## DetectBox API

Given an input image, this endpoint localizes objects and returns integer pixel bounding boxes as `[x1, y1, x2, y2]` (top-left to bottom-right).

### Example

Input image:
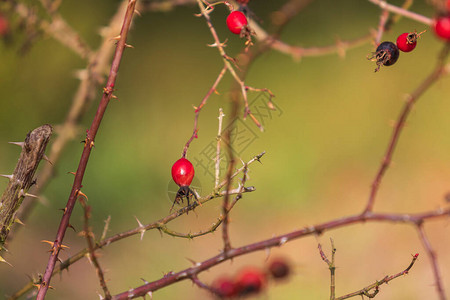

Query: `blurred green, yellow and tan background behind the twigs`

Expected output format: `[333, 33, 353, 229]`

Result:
[0, 0, 450, 299]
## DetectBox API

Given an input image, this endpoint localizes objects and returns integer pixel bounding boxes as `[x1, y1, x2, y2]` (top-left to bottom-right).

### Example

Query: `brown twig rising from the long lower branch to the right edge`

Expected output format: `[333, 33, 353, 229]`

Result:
[363, 43, 450, 214]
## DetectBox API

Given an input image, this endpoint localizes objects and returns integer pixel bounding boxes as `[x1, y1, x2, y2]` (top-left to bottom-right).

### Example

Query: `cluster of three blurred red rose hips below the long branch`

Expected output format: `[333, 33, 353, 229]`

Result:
[212, 258, 291, 299]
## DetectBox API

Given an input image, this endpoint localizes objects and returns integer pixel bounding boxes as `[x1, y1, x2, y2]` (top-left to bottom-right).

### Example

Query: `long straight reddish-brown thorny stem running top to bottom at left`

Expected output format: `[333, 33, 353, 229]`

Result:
[36, 0, 136, 300]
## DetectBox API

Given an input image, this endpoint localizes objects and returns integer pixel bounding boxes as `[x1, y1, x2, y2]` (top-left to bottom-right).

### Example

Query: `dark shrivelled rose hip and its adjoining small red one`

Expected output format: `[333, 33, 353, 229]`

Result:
[369, 31, 425, 72]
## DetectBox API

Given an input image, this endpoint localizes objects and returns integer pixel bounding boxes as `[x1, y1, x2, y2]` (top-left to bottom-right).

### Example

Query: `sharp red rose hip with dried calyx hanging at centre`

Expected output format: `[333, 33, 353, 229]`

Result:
[171, 157, 197, 210]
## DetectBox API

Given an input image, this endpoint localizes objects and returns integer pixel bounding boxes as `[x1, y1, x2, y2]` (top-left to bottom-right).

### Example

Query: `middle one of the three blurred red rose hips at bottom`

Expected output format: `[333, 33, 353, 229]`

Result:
[236, 267, 266, 296]
